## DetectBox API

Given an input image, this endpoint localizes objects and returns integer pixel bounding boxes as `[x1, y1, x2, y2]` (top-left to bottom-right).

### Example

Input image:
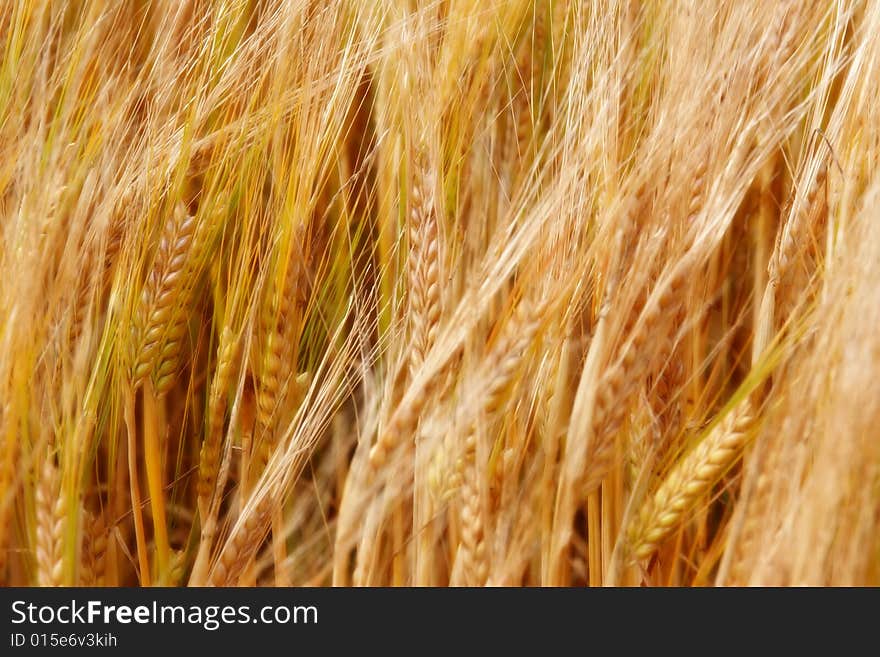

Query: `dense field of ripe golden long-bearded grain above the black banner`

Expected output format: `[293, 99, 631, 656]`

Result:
[0, 0, 880, 586]
